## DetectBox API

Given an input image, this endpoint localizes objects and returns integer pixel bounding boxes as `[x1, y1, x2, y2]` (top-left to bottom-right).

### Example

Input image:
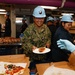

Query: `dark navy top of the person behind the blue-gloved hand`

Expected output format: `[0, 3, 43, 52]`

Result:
[52, 26, 73, 62]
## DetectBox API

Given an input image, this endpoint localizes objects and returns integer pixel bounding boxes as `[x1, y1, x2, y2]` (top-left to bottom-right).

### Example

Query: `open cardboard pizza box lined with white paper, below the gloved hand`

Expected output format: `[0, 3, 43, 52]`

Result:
[36, 53, 75, 75]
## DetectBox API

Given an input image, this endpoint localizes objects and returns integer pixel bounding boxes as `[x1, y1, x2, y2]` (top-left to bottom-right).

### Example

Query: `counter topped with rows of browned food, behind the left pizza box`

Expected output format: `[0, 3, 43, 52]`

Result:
[0, 37, 22, 55]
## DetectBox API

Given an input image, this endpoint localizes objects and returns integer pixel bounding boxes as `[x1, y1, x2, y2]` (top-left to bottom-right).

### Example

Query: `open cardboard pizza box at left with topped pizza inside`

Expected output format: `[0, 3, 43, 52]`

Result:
[0, 54, 30, 75]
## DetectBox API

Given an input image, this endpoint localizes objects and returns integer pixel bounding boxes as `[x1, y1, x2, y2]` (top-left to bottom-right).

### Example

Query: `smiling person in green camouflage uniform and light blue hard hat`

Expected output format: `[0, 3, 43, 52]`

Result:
[22, 6, 51, 71]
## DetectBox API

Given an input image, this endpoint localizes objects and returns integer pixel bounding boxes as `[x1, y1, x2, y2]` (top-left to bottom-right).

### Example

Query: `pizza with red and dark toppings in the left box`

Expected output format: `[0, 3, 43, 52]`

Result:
[4, 64, 24, 75]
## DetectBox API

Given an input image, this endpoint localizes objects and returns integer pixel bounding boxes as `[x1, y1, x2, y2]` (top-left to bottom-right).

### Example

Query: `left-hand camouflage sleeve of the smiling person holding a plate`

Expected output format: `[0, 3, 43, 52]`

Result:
[22, 28, 33, 52]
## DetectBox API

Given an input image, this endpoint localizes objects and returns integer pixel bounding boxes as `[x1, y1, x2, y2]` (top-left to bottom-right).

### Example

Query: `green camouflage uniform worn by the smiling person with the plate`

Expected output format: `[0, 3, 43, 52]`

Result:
[22, 23, 51, 60]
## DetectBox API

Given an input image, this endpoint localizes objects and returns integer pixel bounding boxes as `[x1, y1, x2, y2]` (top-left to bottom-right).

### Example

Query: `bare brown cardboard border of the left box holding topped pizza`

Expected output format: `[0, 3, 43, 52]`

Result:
[0, 54, 30, 75]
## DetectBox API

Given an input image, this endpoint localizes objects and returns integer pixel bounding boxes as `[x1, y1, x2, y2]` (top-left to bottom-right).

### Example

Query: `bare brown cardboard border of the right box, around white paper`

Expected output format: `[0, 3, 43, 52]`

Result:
[36, 61, 74, 75]
